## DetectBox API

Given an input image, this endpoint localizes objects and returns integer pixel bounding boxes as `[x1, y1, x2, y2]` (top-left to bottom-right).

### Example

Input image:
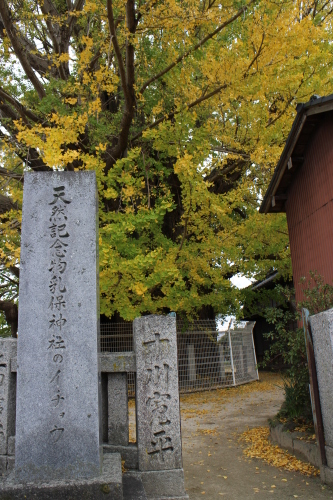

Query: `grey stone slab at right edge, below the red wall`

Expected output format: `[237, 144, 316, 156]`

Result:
[309, 309, 333, 447]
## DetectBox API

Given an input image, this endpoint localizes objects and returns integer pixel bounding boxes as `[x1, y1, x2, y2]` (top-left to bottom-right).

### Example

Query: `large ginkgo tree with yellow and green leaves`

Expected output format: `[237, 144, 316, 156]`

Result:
[0, 0, 333, 331]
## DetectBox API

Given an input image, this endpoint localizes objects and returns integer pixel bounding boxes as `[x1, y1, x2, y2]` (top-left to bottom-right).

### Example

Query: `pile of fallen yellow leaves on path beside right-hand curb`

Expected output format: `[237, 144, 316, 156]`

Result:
[239, 427, 319, 478]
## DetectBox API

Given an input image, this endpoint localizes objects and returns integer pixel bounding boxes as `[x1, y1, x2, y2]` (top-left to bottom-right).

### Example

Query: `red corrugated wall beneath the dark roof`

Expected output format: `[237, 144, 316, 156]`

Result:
[286, 120, 333, 301]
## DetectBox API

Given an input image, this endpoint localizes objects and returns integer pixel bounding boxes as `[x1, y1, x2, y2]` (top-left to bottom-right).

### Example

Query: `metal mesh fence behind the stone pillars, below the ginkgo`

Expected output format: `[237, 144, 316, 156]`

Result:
[100, 319, 259, 396]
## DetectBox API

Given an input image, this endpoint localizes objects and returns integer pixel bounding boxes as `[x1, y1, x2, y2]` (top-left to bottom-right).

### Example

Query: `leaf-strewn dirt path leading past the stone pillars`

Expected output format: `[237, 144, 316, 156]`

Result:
[181, 374, 333, 500]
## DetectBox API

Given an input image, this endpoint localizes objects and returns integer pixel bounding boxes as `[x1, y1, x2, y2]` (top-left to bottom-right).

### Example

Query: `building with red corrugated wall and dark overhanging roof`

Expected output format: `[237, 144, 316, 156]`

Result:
[260, 94, 333, 302]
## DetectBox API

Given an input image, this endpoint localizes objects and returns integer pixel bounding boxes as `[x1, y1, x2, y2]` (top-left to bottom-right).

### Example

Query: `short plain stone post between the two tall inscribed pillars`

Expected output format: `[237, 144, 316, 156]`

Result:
[108, 373, 129, 446]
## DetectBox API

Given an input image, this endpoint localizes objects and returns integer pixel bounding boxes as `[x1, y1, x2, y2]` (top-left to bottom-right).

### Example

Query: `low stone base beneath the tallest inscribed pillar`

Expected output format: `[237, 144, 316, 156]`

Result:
[0, 454, 123, 500]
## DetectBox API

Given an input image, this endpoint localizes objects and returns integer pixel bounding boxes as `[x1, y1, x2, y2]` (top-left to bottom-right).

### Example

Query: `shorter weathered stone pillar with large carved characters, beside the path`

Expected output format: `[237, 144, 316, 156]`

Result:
[133, 316, 182, 471]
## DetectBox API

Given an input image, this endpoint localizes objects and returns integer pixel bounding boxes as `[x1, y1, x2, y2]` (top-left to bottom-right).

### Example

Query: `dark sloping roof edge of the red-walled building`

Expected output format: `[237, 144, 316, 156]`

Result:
[259, 94, 333, 214]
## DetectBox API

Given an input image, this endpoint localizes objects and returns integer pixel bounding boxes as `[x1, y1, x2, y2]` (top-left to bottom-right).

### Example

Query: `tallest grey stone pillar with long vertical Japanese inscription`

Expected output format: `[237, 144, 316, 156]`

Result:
[15, 172, 101, 481]
